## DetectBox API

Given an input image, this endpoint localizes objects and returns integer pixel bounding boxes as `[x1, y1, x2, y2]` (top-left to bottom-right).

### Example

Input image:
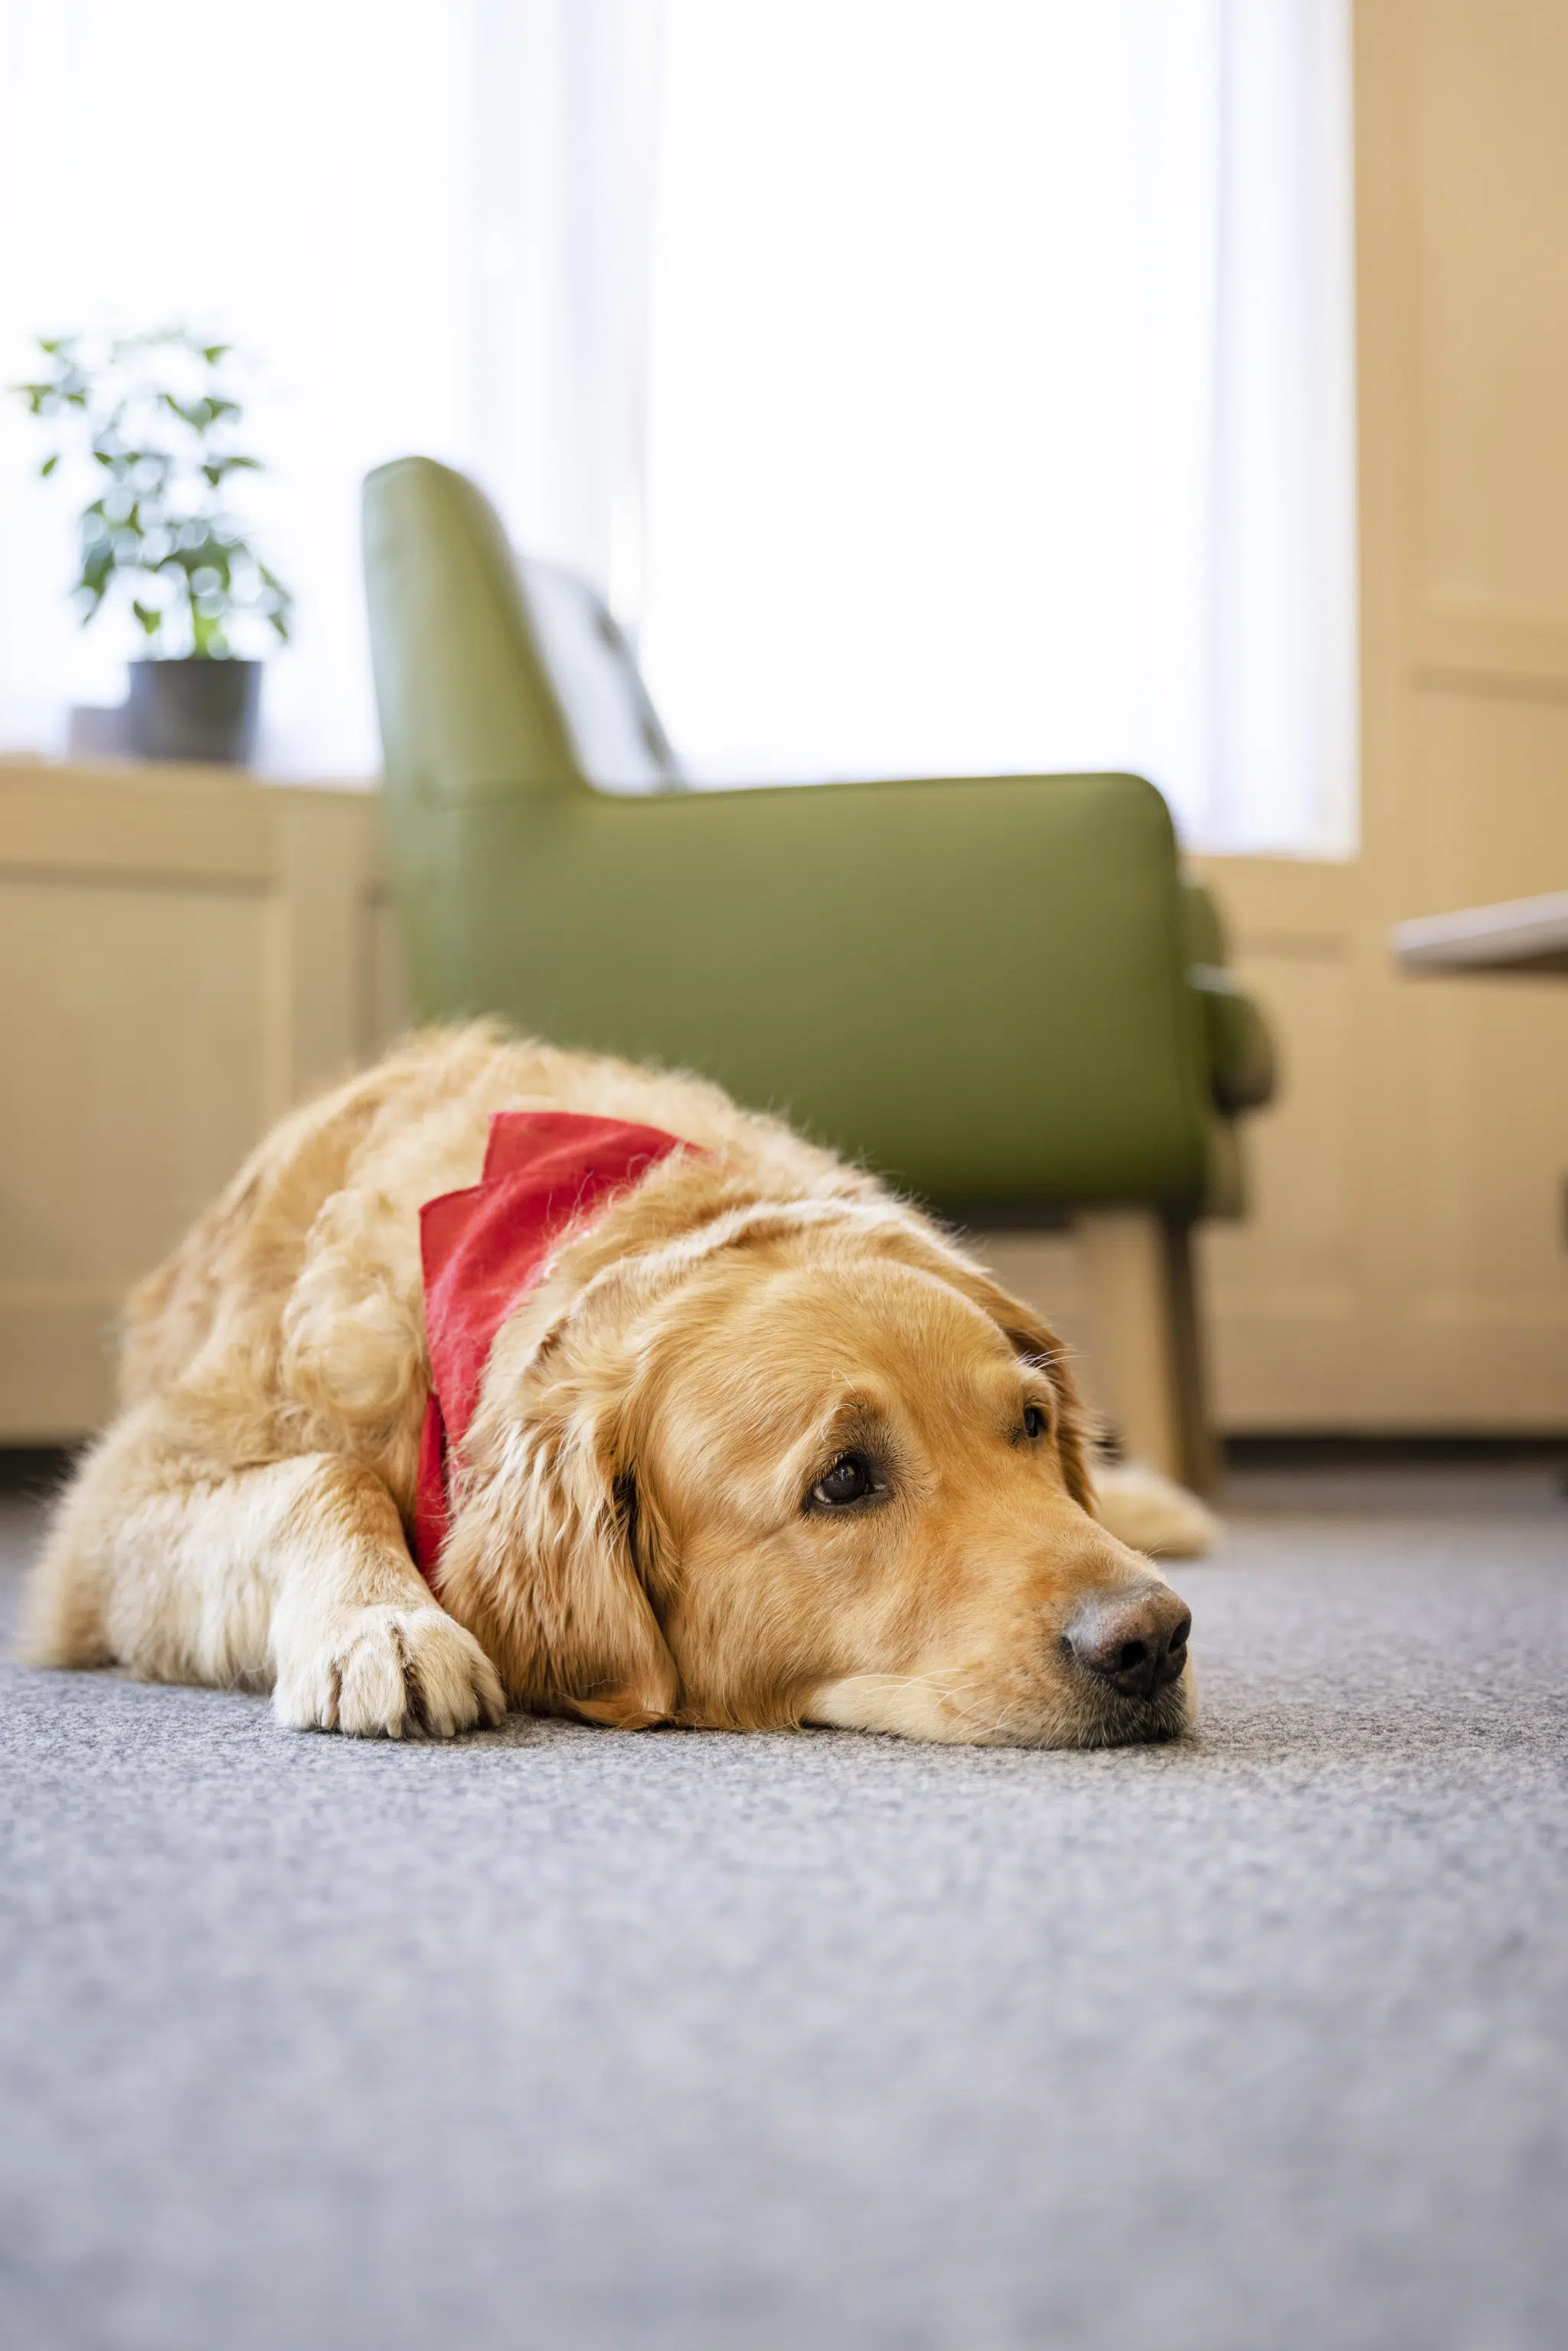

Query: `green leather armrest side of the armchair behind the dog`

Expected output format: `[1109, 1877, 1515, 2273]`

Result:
[388, 776, 1208, 1206]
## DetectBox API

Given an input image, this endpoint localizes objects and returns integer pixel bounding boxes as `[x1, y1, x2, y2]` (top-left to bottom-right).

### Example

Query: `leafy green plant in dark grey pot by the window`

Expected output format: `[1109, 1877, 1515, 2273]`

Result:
[11, 327, 292, 764]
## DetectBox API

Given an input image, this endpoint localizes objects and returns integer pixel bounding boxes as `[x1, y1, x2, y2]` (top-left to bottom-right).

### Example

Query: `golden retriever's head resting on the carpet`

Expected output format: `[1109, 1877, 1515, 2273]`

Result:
[442, 1201, 1190, 1747]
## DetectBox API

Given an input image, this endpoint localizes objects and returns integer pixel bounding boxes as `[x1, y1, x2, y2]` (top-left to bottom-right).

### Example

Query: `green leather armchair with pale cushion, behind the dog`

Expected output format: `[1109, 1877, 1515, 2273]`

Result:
[364, 456, 1272, 1484]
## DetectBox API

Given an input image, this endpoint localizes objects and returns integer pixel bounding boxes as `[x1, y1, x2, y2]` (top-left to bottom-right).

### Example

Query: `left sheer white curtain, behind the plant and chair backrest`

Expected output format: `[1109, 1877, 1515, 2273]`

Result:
[0, 0, 658, 779]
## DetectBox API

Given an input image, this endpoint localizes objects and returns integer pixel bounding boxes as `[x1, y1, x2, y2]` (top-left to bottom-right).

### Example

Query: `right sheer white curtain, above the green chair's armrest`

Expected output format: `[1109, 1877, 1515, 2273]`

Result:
[644, 0, 1357, 849]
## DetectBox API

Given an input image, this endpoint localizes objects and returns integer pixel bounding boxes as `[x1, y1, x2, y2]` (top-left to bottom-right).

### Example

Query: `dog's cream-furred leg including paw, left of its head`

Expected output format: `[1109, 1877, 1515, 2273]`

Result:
[26, 1406, 505, 1737]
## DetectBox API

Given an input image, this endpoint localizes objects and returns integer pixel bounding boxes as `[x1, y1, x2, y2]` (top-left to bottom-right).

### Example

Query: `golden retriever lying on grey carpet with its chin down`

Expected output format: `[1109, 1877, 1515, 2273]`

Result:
[28, 1027, 1192, 1747]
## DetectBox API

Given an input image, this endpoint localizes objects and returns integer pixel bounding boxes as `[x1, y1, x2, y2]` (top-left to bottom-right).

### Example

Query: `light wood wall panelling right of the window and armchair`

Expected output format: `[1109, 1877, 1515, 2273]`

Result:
[1184, 0, 1568, 1432]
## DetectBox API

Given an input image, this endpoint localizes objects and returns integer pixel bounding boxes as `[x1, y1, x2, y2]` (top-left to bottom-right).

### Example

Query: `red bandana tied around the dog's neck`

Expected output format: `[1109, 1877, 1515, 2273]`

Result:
[413, 1110, 684, 1582]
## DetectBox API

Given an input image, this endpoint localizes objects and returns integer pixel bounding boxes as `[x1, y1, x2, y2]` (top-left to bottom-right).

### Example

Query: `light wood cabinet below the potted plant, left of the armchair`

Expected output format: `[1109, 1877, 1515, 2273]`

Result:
[0, 759, 402, 1444]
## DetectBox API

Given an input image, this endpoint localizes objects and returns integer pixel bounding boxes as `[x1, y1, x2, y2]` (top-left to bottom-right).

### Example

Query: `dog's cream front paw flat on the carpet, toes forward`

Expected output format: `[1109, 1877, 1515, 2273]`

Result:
[273, 1608, 505, 1740]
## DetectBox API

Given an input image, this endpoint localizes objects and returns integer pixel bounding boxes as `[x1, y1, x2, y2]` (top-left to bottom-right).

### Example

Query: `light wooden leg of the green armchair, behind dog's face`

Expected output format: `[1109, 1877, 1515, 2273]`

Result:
[1076, 1208, 1218, 1493]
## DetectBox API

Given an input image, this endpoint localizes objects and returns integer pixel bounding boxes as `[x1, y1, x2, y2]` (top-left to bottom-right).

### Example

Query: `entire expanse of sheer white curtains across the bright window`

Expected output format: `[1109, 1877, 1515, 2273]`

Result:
[0, 0, 1357, 851]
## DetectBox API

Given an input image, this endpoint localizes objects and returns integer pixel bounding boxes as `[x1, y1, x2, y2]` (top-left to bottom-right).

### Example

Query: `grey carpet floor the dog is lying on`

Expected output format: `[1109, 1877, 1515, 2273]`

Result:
[0, 1471, 1568, 2351]
